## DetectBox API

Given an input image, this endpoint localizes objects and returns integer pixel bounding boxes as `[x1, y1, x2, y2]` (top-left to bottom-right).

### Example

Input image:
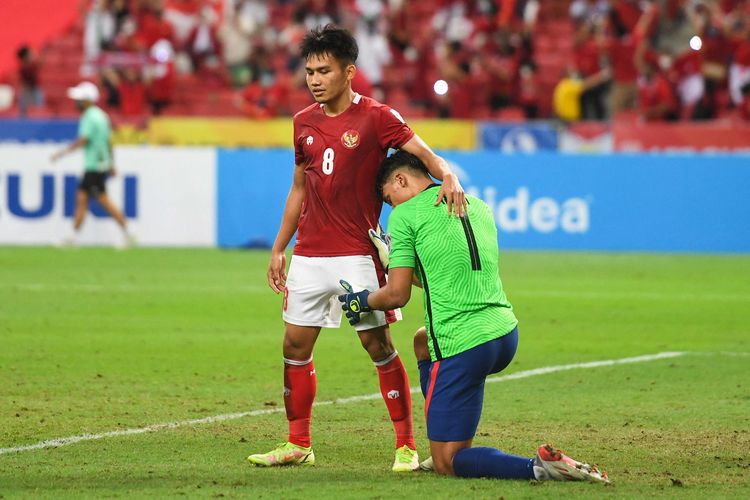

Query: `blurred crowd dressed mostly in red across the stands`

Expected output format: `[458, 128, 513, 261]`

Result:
[10, 0, 750, 122]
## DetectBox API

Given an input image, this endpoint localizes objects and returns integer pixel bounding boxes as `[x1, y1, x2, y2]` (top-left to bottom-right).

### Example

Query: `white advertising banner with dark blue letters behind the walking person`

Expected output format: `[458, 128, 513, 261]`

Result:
[0, 144, 216, 246]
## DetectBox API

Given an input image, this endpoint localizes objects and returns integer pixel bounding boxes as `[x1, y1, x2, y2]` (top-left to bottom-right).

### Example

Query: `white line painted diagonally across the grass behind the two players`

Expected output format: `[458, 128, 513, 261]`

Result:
[0, 352, 688, 455]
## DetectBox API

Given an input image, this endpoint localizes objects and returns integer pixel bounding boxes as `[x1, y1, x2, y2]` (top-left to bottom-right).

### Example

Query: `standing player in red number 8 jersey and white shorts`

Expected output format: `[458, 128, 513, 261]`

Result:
[248, 25, 465, 472]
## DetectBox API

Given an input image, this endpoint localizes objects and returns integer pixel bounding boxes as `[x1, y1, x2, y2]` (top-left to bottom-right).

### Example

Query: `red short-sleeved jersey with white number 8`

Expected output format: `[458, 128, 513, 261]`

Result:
[294, 94, 414, 262]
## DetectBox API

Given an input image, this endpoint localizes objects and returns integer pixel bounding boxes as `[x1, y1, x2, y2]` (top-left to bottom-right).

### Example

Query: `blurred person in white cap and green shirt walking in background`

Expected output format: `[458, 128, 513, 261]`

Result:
[52, 82, 134, 247]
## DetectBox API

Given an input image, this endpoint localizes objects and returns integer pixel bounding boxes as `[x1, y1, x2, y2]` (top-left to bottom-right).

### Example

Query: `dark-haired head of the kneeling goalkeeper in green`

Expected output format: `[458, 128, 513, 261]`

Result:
[375, 150, 433, 207]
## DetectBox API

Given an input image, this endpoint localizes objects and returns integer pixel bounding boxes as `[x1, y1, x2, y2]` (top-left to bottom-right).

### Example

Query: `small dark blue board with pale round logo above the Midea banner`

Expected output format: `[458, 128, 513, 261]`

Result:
[479, 122, 558, 153]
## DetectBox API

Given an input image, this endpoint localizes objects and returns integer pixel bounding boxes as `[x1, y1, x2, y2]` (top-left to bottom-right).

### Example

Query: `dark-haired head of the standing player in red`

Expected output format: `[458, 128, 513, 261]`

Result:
[300, 24, 359, 103]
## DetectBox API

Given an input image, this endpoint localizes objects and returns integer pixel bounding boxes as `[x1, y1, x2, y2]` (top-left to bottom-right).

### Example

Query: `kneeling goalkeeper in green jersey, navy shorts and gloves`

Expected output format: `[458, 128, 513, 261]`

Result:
[339, 151, 607, 482]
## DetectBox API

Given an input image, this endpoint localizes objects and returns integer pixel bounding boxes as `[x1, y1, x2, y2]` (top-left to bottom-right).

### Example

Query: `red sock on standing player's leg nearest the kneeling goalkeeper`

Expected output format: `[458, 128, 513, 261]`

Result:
[375, 352, 417, 450]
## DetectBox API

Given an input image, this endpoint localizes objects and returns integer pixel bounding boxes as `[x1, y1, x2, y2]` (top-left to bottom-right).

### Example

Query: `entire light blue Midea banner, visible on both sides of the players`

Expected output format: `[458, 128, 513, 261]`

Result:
[217, 150, 750, 252]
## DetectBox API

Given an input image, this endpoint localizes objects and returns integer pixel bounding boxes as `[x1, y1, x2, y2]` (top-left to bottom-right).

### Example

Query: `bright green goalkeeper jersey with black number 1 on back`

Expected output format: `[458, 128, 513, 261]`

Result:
[388, 185, 518, 361]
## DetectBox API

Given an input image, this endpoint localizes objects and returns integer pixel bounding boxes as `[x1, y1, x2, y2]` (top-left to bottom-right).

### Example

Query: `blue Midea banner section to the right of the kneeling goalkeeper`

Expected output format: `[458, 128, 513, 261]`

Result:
[444, 153, 750, 252]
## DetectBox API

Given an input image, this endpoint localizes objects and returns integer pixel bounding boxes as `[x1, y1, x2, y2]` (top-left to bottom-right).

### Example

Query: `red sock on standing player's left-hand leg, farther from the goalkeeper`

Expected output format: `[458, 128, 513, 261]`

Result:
[284, 358, 317, 448]
